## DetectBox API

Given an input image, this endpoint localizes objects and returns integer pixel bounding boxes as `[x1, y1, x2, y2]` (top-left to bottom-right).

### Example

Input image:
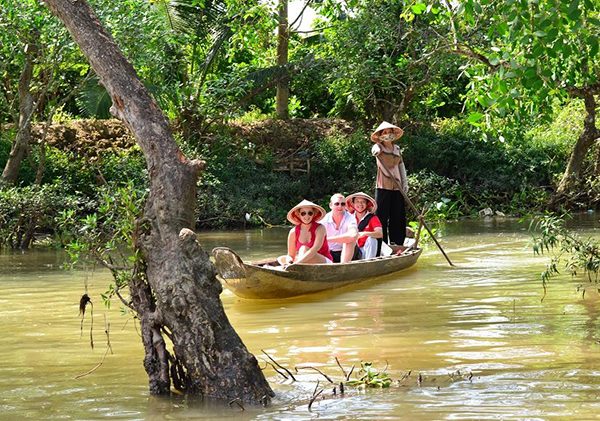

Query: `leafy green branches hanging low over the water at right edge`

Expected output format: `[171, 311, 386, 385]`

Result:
[530, 215, 600, 289]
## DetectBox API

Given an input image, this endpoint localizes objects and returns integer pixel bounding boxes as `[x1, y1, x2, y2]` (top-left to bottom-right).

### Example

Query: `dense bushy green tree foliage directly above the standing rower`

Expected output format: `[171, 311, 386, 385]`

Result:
[318, 0, 458, 121]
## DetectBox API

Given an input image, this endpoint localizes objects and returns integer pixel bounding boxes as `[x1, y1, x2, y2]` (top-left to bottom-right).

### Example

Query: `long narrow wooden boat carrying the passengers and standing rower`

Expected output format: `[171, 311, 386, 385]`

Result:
[212, 247, 421, 299]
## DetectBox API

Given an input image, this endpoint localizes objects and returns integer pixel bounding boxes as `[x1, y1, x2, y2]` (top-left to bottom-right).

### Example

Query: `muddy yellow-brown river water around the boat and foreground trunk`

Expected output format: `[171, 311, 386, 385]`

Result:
[0, 217, 600, 420]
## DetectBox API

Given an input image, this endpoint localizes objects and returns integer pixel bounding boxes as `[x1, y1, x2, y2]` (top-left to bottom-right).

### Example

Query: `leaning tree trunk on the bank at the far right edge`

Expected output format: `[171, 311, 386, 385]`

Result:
[552, 91, 600, 203]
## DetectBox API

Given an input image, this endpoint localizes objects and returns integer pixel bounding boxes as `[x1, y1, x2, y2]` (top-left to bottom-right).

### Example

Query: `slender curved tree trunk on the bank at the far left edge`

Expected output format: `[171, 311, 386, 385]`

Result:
[2, 44, 38, 184]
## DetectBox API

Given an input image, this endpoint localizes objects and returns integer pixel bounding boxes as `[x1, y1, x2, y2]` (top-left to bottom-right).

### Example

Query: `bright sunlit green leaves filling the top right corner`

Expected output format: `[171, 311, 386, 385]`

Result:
[434, 0, 600, 125]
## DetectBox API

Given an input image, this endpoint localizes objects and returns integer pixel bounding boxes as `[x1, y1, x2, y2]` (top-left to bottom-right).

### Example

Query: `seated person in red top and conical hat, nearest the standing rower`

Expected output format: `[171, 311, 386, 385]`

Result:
[346, 192, 383, 259]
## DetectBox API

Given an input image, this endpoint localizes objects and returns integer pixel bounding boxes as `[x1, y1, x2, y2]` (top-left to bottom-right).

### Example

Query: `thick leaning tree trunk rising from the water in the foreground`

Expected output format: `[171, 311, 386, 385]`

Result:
[45, 0, 273, 404]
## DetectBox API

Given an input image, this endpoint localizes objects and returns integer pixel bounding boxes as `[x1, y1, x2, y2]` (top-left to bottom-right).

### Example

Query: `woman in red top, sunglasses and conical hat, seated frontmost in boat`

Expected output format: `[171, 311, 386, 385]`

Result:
[277, 200, 333, 265]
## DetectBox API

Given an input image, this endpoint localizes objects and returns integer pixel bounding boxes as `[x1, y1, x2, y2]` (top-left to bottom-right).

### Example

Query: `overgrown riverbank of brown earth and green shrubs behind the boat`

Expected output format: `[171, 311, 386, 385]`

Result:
[0, 115, 600, 246]
